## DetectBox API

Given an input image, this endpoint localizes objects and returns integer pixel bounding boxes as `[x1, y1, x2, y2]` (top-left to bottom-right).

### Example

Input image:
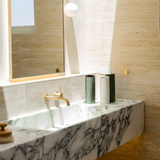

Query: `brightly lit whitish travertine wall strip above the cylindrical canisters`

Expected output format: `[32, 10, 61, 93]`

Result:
[86, 0, 116, 72]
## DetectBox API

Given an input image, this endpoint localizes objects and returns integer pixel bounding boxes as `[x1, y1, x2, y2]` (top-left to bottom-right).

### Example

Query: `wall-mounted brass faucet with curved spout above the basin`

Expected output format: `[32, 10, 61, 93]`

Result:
[44, 87, 70, 106]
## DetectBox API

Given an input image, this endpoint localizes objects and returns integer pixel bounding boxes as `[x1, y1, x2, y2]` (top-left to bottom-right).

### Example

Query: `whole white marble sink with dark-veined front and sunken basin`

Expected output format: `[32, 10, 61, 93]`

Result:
[0, 99, 144, 160]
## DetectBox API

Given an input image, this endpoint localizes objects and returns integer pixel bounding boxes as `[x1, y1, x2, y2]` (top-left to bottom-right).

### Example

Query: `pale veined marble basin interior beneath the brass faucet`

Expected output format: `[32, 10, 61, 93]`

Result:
[3, 100, 140, 131]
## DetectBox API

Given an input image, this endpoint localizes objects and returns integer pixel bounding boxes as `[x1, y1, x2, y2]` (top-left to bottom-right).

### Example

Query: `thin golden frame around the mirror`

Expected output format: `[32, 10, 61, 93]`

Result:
[8, 0, 66, 83]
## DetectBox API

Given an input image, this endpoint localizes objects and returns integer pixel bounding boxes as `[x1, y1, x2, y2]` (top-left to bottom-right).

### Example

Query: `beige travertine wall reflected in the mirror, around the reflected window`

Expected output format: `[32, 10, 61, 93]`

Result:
[12, 0, 63, 78]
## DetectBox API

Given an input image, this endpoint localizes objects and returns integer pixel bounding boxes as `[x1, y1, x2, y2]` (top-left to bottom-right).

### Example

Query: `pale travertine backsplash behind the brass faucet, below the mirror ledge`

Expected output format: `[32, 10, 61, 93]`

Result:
[0, 75, 91, 121]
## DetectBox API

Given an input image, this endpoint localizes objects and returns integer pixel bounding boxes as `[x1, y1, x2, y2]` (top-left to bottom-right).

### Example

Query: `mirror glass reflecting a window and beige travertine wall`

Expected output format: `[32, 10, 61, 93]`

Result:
[10, 0, 65, 79]
